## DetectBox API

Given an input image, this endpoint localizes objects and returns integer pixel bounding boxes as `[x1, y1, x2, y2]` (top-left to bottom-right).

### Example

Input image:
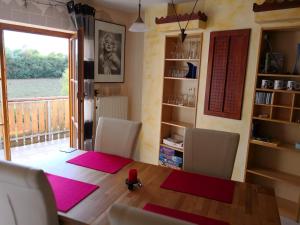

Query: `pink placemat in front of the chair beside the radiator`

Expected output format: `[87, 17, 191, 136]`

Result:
[67, 152, 132, 173]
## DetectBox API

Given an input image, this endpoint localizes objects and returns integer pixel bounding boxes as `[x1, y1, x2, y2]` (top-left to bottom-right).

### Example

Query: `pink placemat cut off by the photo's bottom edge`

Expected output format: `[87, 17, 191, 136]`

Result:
[144, 203, 229, 225]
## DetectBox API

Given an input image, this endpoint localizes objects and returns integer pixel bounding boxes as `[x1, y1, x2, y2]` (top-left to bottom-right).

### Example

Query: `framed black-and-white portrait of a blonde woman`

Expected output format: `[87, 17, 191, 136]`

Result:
[95, 20, 126, 83]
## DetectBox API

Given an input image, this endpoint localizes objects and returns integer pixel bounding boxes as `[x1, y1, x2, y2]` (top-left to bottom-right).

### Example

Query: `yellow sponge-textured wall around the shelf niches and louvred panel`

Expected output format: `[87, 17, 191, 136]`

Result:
[139, 0, 299, 180]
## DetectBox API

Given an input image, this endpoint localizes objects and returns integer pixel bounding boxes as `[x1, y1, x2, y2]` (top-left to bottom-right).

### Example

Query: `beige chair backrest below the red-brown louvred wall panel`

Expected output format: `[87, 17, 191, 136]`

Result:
[184, 128, 240, 179]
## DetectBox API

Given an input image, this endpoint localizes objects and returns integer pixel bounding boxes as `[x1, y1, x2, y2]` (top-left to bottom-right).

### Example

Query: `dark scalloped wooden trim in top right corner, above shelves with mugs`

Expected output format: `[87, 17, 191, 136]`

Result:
[253, 0, 300, 12]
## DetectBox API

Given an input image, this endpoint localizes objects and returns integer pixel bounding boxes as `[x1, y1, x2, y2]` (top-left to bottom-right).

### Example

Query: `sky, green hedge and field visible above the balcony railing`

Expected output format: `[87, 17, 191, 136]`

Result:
[4, 31, 68, 99]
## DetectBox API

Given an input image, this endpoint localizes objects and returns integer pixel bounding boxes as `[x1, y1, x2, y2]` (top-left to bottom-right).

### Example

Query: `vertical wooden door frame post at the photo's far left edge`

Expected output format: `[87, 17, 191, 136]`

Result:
[0, 29, 11, 160]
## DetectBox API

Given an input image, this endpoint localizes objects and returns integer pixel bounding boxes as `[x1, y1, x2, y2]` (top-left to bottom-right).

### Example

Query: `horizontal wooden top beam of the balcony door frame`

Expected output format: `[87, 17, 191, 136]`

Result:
[0, 23, 75, 38]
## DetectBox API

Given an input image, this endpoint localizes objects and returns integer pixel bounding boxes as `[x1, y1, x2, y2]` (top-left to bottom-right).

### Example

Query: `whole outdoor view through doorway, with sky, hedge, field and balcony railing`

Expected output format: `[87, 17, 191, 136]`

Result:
[0, 31, 69, 160]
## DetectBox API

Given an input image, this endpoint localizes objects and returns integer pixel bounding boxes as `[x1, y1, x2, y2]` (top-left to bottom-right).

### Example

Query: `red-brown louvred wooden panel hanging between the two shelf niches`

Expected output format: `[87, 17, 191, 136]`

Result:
[204, 29, 250, 119]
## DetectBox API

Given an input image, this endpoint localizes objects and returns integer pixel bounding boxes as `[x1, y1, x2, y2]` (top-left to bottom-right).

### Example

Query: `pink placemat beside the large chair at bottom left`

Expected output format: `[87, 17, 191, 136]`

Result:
[46, 173, 99, 212]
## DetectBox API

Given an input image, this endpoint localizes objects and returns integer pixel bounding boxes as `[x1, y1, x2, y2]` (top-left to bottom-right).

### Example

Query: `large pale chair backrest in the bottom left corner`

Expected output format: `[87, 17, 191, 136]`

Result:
[0, 161, 58, 225]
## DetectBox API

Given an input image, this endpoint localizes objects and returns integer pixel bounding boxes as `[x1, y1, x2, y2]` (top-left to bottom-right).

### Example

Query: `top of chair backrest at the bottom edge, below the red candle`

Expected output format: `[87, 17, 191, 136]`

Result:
[108, 204, 194, 225]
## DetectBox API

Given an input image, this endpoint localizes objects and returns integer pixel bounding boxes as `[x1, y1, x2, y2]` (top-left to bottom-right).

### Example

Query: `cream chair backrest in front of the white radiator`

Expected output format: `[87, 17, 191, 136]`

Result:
[94, 117, 141, 158]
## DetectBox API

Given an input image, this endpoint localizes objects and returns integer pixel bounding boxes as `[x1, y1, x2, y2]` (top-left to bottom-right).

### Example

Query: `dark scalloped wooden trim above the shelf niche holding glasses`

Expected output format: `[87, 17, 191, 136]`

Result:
[155, 11, 207, 24]
